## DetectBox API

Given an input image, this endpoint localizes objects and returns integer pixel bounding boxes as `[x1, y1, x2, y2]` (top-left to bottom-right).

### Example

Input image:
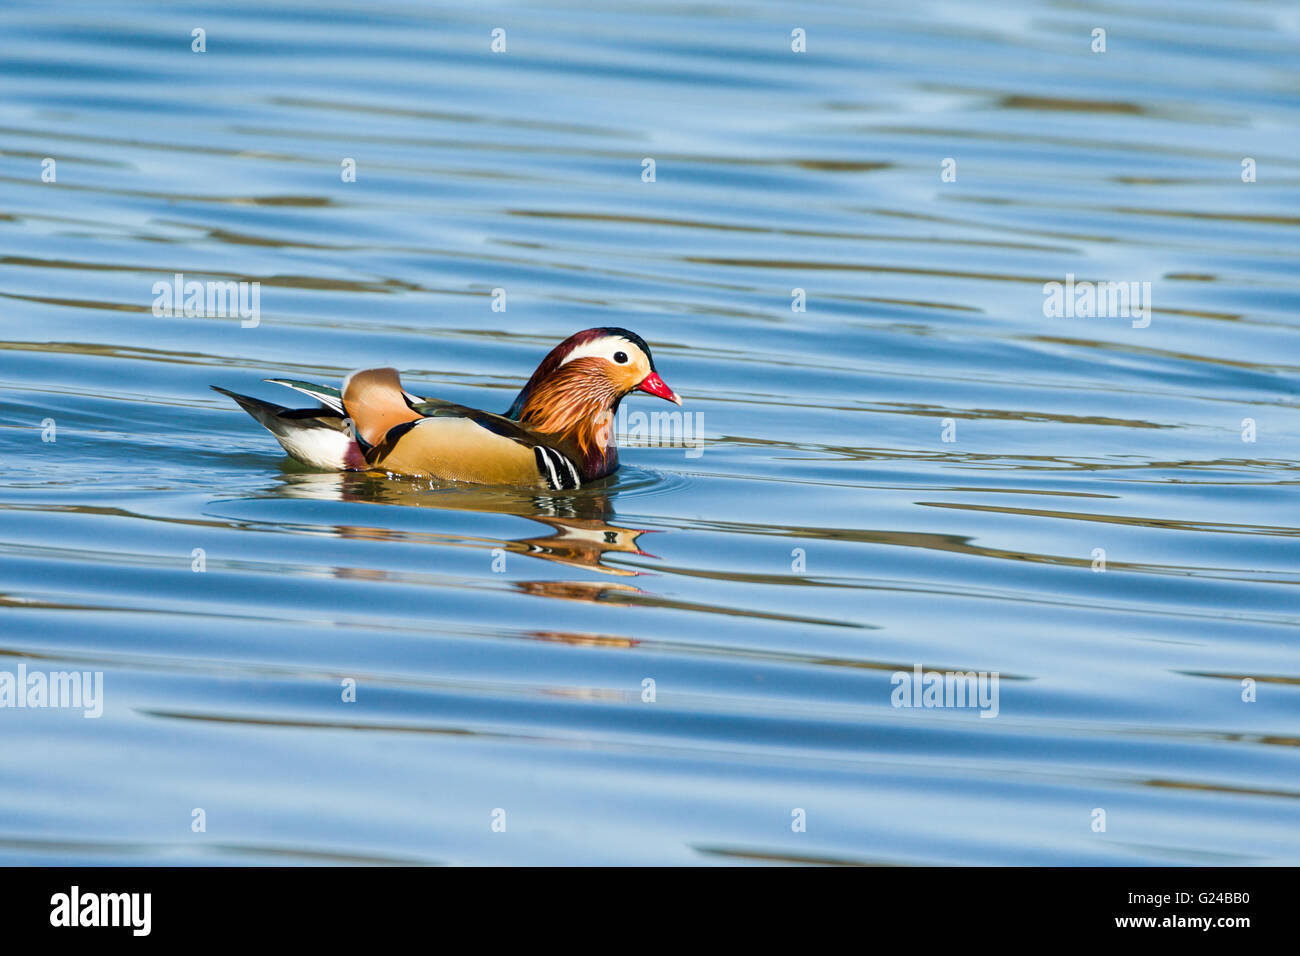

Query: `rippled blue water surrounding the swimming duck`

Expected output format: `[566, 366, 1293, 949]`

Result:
[0, 0, 1300, 864]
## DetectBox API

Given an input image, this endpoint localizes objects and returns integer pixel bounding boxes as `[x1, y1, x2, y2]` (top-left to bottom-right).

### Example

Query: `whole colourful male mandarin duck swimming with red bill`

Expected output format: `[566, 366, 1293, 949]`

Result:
[212, 328, 681, 490]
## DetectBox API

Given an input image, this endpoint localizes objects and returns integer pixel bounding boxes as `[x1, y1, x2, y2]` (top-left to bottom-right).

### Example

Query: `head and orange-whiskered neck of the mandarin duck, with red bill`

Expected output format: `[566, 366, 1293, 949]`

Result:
[506, 328, 681, 477]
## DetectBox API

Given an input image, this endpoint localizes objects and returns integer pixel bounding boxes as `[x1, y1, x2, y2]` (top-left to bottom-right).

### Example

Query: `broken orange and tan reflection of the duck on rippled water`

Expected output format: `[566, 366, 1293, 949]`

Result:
[276, 472, 655, 580]
